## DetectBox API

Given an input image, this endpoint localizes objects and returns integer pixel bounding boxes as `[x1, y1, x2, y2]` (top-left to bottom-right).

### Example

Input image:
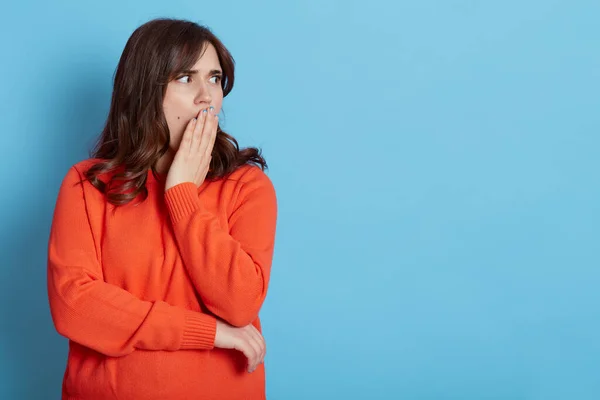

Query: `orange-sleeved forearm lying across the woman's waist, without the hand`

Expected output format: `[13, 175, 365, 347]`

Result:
[48, 263, 216, 357]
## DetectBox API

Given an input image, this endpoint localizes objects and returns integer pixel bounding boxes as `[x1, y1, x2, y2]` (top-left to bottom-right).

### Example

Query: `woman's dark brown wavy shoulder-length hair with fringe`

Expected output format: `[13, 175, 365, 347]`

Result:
[85, 18, 267, 206]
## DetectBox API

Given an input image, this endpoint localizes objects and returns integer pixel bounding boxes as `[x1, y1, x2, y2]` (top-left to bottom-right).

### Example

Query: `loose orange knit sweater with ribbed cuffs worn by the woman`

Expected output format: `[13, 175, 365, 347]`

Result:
[48, 160, 277, 400]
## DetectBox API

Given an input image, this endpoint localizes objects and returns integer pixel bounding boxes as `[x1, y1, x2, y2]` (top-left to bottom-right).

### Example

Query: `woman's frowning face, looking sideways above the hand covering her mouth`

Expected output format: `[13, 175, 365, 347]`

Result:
[163, 44, 223, 151]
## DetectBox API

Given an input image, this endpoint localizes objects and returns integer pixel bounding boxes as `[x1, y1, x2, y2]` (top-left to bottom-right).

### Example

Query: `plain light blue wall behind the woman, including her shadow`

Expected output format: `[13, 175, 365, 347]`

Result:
[0, 0, 600, 400]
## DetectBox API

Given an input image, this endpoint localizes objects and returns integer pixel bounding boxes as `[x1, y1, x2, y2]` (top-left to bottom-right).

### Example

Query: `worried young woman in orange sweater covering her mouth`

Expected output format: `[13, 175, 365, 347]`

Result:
[48, 19, 277, 400]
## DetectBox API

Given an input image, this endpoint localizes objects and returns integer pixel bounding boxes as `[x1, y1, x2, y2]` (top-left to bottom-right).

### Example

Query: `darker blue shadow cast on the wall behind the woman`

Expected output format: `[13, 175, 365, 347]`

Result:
[0, 58, 113, 399]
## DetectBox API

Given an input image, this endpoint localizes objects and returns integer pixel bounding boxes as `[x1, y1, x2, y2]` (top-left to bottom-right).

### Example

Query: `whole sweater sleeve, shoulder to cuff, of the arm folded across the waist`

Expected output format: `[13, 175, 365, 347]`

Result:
[47, 167, 216, 357]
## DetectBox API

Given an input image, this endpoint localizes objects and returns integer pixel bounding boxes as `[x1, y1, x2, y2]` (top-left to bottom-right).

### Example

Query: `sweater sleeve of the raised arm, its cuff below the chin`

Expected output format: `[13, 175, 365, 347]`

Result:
[165, 167, 277, 326]
